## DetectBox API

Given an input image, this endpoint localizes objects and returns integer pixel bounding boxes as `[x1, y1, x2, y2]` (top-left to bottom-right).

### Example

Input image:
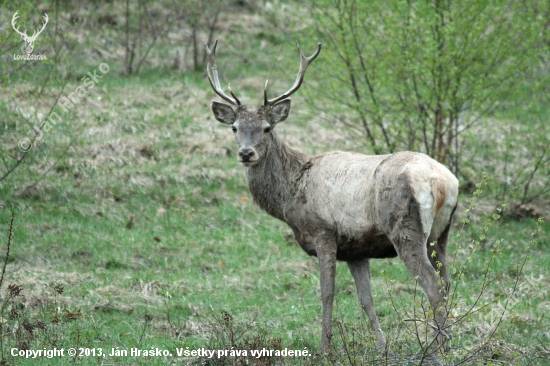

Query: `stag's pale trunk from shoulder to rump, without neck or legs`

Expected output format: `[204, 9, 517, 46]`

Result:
[281, 152, 456, 261]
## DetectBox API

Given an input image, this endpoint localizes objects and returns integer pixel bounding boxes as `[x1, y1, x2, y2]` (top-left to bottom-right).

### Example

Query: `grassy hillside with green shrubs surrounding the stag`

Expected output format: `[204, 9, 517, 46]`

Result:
[0, 0, 550, 365]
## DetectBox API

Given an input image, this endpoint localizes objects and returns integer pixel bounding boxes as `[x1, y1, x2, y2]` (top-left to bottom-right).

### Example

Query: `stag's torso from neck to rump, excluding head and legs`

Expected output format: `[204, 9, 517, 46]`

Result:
[246, 143, 456, 261]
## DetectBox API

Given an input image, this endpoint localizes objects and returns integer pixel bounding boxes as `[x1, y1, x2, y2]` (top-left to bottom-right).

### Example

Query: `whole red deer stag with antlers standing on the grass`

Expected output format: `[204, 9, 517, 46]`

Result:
[205, 40, 458, 351]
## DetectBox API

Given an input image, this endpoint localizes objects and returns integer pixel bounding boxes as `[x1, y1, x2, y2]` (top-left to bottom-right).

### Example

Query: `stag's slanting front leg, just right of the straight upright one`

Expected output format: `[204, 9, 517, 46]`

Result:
[347, 258, 386, 350]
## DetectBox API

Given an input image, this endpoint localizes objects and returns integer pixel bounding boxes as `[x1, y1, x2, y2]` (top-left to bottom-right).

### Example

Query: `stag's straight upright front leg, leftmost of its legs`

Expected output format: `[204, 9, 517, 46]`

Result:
[316, 242, 336, 352]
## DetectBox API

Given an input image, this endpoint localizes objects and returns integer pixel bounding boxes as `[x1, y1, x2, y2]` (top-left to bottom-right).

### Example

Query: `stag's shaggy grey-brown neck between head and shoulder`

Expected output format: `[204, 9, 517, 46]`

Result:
[246, 131, 309, 222]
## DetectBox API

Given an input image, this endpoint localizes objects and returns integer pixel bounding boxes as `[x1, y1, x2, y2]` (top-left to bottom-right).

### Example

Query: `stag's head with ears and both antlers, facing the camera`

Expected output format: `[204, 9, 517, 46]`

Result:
[205, 40, 321, 167]
